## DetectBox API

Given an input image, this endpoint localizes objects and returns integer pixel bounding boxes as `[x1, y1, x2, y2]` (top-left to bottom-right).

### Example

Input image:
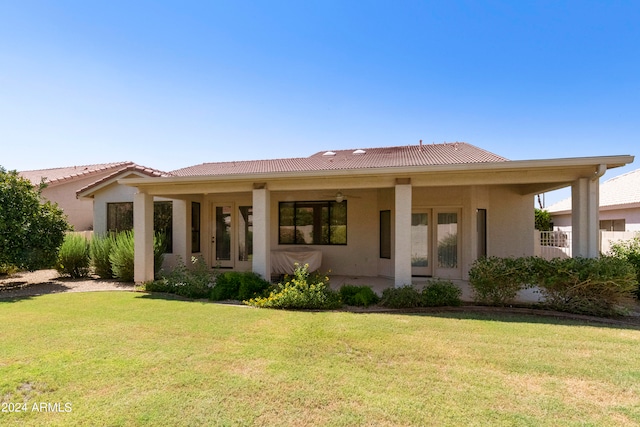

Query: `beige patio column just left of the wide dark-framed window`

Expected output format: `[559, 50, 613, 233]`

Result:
[252, 183, 271, 280]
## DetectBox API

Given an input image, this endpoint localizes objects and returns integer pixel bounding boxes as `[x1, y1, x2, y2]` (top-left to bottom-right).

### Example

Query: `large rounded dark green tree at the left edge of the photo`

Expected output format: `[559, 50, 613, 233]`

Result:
[0, 166, 71, 271]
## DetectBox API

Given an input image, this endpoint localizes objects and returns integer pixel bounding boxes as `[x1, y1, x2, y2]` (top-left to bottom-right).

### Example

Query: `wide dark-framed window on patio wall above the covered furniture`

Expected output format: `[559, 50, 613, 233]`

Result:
[278, 201, 347, 245]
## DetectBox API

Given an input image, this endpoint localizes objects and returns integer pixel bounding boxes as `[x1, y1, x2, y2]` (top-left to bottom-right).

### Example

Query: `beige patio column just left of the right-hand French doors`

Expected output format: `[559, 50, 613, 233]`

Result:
[393, 178, 412, 288]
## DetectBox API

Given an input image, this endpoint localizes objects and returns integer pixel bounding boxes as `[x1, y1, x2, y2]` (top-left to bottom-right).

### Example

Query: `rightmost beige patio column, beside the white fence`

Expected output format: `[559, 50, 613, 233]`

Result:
[571, 178, 600, 258]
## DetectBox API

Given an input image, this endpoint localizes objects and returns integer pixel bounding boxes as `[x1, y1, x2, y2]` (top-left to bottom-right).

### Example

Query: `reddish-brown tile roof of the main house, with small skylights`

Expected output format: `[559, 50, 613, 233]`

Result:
[171, 142, 507, 176]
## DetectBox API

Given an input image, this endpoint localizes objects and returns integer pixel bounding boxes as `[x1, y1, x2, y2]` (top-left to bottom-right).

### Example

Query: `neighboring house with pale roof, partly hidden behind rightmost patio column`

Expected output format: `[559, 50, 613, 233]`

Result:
[547, 169, 640, 231]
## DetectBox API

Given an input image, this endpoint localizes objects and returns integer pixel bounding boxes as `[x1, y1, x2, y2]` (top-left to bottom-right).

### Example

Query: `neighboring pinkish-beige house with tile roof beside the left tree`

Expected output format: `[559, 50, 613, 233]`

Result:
[20, 162, 159, 231]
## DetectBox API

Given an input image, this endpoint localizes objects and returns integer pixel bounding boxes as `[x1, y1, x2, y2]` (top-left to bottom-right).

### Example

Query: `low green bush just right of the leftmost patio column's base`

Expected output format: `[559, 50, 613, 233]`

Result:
[145, 257, 214, 298]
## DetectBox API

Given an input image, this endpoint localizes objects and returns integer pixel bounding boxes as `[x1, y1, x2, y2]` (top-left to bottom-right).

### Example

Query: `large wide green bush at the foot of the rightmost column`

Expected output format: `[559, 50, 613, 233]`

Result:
[532, 256, 638, 316]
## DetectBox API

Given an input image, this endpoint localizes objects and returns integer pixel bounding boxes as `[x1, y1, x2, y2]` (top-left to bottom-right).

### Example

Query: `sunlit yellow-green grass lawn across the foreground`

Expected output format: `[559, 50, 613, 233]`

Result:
[0, 292, 640, 426]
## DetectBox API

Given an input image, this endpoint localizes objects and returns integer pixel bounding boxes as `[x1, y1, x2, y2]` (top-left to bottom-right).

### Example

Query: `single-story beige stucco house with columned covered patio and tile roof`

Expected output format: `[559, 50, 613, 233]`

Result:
[78, 142, 633, 286]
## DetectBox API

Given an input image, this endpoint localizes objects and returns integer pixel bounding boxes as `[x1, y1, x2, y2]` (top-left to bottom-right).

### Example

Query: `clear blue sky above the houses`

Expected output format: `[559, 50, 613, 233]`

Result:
[0, 0, 640, 206]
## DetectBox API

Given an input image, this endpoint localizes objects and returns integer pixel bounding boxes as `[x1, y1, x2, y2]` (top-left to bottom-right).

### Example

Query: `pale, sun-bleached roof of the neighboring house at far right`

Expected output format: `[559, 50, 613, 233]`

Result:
[547, 169, 640, 212]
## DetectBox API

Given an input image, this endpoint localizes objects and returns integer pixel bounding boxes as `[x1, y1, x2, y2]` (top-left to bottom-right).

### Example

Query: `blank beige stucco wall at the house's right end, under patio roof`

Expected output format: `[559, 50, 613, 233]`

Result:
[487, 187, 535, 257]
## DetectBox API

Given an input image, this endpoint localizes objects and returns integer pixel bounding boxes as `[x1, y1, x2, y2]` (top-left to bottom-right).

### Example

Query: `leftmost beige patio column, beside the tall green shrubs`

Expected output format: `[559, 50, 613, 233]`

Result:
[133, 191, 153, 283]
